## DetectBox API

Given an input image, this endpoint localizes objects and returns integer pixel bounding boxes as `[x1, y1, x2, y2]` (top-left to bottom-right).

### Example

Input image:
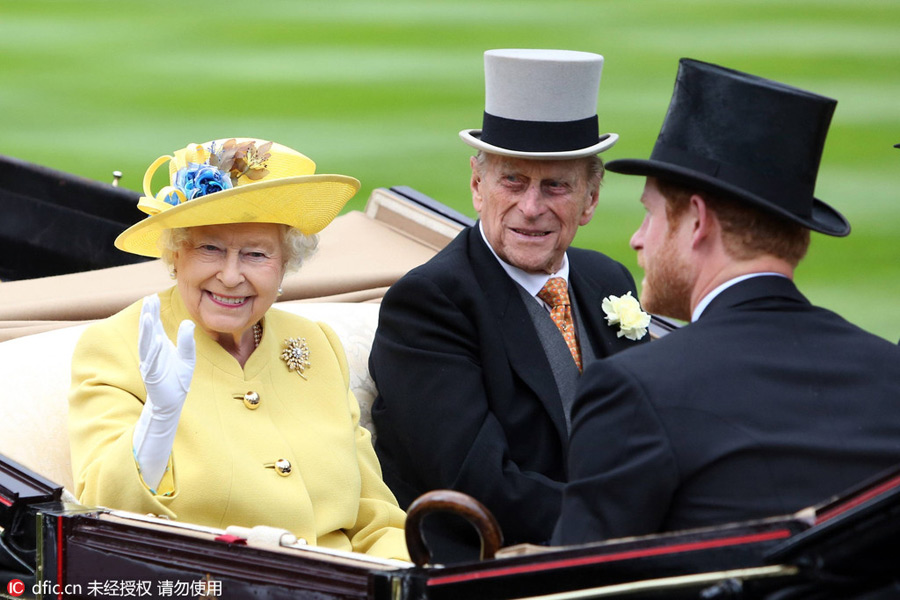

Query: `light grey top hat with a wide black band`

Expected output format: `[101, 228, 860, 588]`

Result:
[459, 49, 619, 160]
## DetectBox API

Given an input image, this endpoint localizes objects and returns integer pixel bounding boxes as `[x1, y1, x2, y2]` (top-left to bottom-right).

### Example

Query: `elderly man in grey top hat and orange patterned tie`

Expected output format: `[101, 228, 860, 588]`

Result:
[369, 50, 647, 562]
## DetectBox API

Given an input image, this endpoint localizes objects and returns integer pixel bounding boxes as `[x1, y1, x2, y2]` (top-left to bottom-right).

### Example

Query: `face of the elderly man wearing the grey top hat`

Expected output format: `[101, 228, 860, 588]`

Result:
[471, 155, 598, 273]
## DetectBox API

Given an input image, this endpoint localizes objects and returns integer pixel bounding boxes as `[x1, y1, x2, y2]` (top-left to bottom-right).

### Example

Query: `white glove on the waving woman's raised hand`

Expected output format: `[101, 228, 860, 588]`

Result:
[132, 294, 196, 489]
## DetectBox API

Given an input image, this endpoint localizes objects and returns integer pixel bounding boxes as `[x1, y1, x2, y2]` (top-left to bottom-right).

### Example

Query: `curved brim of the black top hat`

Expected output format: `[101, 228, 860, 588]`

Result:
[606, 158, 850, 237]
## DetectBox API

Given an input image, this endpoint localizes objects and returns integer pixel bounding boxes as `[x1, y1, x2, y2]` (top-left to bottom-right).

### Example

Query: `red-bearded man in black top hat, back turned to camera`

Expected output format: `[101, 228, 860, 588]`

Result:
[554, 60, 900, 544]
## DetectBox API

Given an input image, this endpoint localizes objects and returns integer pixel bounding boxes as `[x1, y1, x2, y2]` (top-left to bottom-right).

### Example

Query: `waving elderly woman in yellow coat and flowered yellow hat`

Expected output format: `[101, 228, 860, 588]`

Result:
[69, 139, 408, 559]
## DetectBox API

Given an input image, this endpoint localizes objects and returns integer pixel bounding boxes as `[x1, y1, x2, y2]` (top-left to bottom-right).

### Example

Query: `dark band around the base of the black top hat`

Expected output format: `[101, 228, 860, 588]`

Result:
[650, 141, 813, 217]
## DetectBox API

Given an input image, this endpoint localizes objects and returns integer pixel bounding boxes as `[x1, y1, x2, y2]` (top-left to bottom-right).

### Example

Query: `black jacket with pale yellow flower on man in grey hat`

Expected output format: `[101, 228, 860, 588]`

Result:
[369, 225, 649, 562]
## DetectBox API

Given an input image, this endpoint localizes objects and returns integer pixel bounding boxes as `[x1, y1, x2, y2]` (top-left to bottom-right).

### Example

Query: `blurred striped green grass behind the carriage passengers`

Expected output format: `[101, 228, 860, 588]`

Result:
[0, 0, 900, 341]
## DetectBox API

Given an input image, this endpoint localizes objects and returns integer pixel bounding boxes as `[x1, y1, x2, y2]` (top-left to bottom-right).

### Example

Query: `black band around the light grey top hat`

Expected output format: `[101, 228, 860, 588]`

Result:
[481, 113, 600, 152]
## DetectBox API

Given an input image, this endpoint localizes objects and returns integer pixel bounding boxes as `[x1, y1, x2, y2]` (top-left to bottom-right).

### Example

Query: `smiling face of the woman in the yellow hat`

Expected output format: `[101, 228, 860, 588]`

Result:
[173, 223, 284, 344]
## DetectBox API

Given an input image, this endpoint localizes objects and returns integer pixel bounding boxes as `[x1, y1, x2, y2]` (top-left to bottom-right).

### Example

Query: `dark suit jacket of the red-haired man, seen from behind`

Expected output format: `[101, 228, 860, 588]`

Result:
[554, 276, 900, 544]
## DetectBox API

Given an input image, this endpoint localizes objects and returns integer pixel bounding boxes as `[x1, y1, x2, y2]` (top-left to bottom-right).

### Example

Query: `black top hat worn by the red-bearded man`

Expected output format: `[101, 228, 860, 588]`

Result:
[607, 58, 850, 236]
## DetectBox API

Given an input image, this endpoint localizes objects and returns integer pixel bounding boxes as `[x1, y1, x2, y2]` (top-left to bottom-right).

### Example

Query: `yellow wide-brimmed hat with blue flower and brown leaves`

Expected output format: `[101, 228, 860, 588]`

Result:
[115, 138, 359, 257]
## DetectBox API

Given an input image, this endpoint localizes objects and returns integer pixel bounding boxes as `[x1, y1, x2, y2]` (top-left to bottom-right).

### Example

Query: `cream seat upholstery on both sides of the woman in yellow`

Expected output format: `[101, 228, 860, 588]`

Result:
[0, 302, 379, 490]
